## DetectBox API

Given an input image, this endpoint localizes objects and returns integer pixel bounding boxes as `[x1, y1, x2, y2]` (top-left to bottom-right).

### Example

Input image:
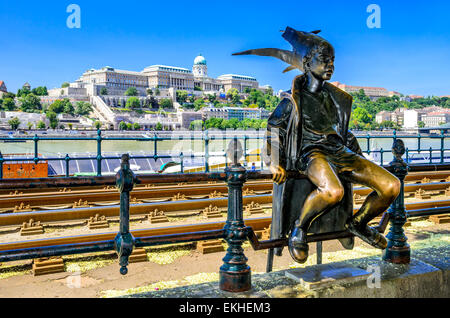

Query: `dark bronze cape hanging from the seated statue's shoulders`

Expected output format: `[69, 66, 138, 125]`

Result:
[264, 75, 360, 255]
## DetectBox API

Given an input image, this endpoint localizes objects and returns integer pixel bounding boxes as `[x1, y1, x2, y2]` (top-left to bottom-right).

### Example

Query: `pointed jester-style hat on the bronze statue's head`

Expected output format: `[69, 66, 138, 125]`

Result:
[233, 27, 331, 73]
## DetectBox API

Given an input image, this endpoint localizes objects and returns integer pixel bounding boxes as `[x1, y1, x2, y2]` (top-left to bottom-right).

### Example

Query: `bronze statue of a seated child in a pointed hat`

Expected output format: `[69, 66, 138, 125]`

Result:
[235, 27, 400, 263]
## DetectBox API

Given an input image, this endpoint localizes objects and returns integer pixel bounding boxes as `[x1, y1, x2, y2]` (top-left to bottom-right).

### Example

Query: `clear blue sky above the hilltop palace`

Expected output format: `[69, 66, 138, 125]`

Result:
[0, 0, 450, 96]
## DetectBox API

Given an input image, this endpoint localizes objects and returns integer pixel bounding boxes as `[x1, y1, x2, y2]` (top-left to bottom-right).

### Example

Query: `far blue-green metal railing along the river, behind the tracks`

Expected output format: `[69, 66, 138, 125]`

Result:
[0, 130, 450, 179]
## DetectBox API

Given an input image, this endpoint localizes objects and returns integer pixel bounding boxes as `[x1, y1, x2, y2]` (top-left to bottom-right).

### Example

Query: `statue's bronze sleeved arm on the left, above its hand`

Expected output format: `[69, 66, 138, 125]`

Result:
[263, 98, 293, 168]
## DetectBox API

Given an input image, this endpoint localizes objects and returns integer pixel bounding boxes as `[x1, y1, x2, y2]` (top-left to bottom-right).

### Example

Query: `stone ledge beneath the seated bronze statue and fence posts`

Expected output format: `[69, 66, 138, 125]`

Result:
[126, 246, 450, 298]
